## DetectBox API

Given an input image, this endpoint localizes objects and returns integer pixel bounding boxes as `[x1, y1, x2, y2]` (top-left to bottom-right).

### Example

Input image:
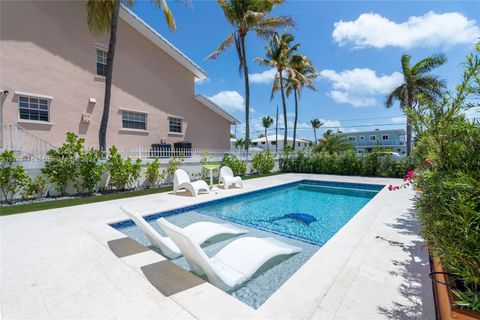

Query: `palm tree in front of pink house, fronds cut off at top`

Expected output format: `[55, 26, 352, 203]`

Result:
[86, 0, 176, 150]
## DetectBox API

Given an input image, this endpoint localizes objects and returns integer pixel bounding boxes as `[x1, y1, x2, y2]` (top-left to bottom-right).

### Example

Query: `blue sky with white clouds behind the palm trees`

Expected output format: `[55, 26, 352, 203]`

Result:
[134, 0, 480, 138]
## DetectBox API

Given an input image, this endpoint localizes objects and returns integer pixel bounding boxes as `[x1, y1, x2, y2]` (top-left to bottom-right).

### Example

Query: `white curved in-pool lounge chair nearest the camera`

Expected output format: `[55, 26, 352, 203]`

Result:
[157, 218, 302, 290]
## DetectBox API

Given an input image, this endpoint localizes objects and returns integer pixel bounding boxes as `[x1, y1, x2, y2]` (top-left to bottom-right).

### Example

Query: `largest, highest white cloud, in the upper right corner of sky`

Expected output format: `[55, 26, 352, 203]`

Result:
[332, 11, 480, 49]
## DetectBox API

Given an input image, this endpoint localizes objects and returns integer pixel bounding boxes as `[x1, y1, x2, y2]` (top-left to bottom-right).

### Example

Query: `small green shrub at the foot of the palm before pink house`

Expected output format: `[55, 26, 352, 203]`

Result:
[78, 149, 105, 194]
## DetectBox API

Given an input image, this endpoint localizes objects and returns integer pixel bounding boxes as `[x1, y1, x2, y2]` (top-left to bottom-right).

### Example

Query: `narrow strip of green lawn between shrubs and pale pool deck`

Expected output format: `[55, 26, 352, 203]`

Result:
[0, 172, 282, 216]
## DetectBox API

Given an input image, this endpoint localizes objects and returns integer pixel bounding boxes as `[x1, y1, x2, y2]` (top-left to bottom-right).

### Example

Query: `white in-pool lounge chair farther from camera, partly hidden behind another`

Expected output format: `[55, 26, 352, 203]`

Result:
[120, 206, 248, 259]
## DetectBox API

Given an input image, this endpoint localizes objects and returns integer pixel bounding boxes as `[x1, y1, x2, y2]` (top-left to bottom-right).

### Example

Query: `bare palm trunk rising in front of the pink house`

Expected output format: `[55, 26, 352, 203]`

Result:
[98, 0, 120, 151]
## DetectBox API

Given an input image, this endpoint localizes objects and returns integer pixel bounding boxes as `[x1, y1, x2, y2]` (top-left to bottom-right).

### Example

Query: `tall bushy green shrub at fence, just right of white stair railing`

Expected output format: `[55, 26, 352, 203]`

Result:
[42, 132, 85, 195]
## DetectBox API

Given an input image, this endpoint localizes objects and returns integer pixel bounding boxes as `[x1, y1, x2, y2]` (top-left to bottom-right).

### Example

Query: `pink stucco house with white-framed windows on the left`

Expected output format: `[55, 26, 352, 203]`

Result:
[0, 1, 238, 149]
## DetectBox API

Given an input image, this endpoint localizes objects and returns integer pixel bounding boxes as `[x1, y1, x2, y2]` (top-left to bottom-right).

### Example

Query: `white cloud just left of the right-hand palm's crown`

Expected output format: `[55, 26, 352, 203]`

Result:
[320, 68, 403, 107]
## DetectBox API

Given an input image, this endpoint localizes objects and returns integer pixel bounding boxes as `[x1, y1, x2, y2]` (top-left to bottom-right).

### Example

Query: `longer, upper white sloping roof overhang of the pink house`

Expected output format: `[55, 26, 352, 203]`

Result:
[120, 5, 207, 80]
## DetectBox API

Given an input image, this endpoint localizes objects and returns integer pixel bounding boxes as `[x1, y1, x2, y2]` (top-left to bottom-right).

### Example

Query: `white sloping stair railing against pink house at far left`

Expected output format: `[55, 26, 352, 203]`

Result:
[0, 124, 55, 161]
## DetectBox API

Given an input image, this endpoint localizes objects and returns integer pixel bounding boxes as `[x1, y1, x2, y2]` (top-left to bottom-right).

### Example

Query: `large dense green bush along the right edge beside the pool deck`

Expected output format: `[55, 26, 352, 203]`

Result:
[408, 43, 480, 311]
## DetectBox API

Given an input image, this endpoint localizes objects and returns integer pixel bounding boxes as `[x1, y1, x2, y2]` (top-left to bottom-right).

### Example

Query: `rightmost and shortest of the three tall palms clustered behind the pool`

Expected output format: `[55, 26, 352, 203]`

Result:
[286, 54, 318, 150]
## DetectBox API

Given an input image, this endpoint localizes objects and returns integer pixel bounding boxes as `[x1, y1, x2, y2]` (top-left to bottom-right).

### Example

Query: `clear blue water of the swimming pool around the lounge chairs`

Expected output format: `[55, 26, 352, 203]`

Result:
[111, 180, 383, 308]
